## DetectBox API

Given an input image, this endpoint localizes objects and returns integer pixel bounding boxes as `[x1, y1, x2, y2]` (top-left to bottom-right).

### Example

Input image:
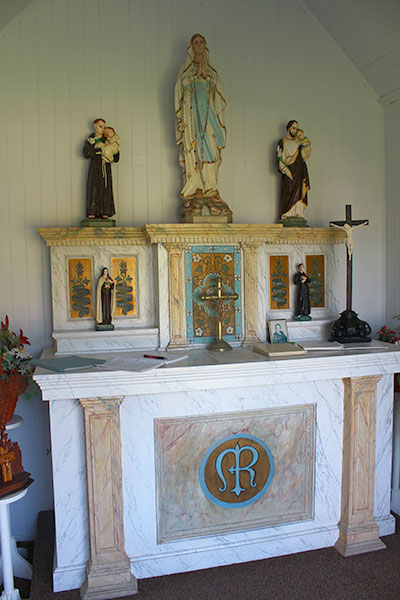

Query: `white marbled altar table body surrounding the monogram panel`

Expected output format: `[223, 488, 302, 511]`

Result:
[34, 343, 400, 591]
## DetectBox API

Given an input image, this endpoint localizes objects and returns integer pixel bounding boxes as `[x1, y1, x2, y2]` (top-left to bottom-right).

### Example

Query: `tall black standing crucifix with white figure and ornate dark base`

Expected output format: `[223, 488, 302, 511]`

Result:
[329, 204, 371, 344]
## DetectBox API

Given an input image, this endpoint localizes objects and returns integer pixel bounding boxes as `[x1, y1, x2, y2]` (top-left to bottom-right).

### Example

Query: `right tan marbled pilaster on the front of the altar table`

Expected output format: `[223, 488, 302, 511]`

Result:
[335, 375, 386, 556]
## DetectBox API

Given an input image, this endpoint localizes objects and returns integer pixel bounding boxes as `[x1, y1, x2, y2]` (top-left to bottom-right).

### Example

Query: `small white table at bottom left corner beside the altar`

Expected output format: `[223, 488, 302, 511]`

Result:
[0, 488, 32, 600]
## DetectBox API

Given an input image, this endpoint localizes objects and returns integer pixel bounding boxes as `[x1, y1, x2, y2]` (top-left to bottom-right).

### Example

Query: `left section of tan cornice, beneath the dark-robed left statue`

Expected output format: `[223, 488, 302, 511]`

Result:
[38, 227, 149, 246]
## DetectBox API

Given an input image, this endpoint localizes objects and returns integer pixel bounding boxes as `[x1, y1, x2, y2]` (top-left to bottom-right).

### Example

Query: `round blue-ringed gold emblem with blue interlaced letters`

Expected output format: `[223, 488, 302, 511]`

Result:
[200, 433, 274, 508]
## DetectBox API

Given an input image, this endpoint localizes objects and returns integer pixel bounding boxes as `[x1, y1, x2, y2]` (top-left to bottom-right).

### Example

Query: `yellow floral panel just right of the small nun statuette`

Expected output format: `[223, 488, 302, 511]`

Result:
[112, 256, 136, 317]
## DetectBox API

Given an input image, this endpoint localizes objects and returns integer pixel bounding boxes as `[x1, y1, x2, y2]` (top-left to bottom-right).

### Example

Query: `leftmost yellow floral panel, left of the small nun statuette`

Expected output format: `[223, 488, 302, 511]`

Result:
[68, 258, 94, 319]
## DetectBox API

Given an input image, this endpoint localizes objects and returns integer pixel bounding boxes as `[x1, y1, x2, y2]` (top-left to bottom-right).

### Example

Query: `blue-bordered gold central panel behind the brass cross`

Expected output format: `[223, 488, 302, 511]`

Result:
[185, 246, 242, 344]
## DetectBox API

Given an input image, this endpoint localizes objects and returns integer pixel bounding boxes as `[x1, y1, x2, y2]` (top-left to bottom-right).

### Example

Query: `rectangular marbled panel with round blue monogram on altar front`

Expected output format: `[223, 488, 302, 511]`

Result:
[155, 404, 315, 543]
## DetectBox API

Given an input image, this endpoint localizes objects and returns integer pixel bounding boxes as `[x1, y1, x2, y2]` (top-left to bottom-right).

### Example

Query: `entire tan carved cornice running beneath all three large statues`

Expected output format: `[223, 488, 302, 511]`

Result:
[38, 223, 346, 246]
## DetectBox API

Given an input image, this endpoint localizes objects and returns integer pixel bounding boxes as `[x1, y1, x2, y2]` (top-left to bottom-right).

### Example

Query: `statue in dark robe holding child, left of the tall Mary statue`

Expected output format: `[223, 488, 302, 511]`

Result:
[83, 119, 120, 220]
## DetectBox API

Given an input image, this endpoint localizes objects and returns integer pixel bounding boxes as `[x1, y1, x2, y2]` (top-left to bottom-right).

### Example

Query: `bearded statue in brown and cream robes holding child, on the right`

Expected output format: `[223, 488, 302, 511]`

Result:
[276, 120, 311, 227]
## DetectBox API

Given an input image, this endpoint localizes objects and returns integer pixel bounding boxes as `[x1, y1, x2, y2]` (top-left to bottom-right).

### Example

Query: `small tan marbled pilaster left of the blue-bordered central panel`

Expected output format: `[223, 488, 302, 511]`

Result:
[164, 242, 187, 348]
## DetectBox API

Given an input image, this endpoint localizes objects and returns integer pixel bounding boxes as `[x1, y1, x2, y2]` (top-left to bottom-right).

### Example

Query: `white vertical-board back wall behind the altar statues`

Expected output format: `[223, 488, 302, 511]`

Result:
[0, 0, 385, 537]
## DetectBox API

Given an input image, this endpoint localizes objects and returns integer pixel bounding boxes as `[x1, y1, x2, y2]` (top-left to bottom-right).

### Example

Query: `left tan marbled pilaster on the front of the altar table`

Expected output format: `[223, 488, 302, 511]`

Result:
[80, 397, 137, 600]
